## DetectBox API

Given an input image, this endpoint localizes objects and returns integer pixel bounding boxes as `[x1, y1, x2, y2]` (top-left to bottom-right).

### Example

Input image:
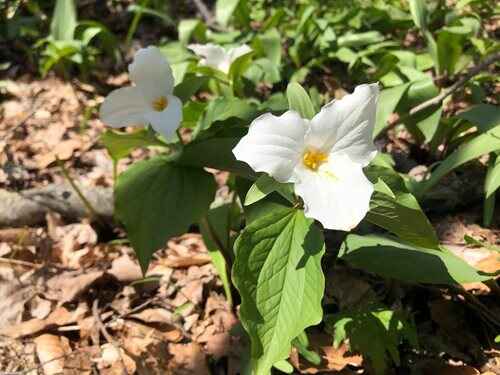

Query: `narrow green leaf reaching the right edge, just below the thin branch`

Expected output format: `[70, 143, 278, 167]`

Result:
[415, 126, 500, 197]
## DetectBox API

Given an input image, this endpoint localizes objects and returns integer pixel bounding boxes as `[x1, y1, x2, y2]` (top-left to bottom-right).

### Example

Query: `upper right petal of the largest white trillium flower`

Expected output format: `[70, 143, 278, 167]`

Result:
[306, 83, 379, 166]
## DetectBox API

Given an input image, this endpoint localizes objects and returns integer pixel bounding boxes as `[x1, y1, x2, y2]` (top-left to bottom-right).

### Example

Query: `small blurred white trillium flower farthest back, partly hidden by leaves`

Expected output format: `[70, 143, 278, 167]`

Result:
[188, 43, 252, 74]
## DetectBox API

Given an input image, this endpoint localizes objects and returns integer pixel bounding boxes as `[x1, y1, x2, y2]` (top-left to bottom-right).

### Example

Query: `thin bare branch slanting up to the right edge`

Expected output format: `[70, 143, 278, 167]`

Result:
[383, 52, 500, 135]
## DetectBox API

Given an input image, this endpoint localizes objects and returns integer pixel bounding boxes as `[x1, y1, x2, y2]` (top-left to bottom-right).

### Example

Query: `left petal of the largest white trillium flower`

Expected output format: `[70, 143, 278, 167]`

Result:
[233, 111, 308, 182]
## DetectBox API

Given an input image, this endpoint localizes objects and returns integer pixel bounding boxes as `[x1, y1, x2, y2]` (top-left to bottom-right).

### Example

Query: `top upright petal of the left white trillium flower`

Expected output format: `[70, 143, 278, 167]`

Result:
[128, 46, 174, 103]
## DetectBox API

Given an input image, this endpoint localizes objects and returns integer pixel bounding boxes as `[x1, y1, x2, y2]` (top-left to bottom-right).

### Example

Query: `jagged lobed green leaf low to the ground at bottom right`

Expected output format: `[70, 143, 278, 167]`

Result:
[325, 306, 417, 374]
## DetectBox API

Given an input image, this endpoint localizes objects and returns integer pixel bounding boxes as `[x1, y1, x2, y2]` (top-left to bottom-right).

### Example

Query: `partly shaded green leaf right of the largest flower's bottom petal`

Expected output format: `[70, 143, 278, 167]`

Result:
[366, 167, 439, 249]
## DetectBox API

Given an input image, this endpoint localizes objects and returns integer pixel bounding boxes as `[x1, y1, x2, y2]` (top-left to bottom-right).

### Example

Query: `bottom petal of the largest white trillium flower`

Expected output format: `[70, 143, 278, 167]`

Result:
[295, 155, 373, 231]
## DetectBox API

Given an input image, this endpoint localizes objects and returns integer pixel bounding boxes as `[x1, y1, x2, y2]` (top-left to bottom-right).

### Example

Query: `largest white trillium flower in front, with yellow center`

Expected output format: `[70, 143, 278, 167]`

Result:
[233, 83, 379, 231]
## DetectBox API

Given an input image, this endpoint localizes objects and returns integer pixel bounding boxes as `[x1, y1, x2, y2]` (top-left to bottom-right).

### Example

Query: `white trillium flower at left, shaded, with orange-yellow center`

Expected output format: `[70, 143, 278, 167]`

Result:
[100, 47, 182, 139]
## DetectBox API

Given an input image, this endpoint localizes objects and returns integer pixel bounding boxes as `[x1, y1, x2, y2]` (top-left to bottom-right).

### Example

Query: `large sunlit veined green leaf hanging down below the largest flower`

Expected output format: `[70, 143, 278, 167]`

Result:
[233, 208, 325, 375]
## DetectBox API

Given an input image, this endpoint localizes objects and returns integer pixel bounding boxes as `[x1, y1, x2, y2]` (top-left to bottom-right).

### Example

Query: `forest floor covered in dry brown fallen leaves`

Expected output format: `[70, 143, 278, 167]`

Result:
[0, 71, 500, 375]
